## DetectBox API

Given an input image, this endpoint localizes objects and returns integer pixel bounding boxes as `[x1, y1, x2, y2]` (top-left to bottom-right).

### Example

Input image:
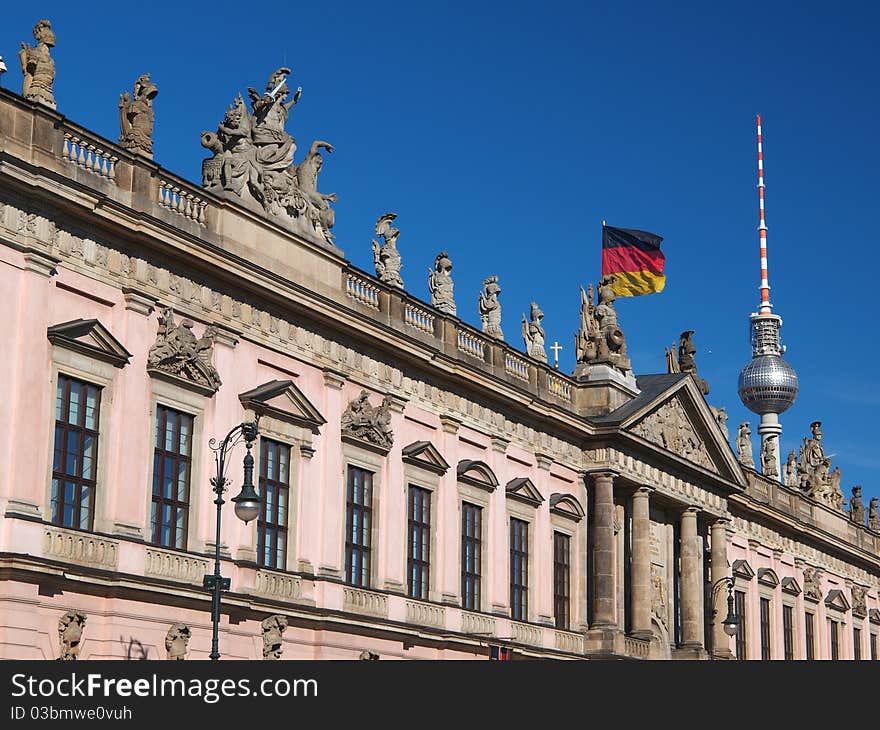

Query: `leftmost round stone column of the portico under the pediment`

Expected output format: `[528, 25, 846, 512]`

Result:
[591, 471, 617, 628]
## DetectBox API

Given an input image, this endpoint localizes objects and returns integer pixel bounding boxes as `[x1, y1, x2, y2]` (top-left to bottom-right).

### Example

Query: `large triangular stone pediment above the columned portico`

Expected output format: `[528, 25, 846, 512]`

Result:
[612, 376, 746, 487]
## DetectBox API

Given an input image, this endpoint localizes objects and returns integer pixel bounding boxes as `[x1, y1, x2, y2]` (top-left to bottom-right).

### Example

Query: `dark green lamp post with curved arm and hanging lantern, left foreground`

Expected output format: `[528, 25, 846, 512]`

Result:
[203, 416, 260, 660]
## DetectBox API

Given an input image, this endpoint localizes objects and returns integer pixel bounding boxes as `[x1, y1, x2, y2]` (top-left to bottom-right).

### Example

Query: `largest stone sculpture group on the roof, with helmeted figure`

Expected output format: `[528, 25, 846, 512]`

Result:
[202, 67, 338, 244]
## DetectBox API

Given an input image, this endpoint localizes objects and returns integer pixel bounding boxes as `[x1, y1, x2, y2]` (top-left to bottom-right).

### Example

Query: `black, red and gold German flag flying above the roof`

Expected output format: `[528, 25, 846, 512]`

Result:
[602, 225, 666, 297]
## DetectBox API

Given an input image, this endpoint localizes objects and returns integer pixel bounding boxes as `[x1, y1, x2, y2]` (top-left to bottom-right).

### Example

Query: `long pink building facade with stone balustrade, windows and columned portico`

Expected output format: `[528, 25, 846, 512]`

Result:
[0, 90, 880, 660]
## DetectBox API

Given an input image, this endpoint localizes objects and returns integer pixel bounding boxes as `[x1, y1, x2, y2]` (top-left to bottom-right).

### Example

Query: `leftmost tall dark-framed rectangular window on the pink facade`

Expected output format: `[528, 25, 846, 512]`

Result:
[52, 373, 101, 530]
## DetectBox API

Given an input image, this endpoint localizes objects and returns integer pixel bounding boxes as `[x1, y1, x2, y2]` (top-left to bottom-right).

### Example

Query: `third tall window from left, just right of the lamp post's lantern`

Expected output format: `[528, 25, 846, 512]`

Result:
[257, 438, 290, 570]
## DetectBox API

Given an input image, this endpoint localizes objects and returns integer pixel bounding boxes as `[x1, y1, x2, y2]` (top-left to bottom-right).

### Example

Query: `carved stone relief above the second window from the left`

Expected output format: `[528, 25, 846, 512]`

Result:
[147, 307, 220, 393]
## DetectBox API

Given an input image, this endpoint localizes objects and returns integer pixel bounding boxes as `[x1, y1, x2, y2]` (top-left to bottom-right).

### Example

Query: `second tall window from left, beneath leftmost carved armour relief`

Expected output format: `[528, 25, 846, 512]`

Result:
[150, 405, 193, 550]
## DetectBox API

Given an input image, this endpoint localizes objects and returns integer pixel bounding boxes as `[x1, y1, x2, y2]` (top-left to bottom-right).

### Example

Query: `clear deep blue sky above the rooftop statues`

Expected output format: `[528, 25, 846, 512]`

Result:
[0, 0, 880, 496]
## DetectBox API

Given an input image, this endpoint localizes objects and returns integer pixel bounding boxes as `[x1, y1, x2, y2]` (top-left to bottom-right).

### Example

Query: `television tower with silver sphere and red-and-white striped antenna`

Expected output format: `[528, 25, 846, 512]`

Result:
[738, 115, 798, 481]
